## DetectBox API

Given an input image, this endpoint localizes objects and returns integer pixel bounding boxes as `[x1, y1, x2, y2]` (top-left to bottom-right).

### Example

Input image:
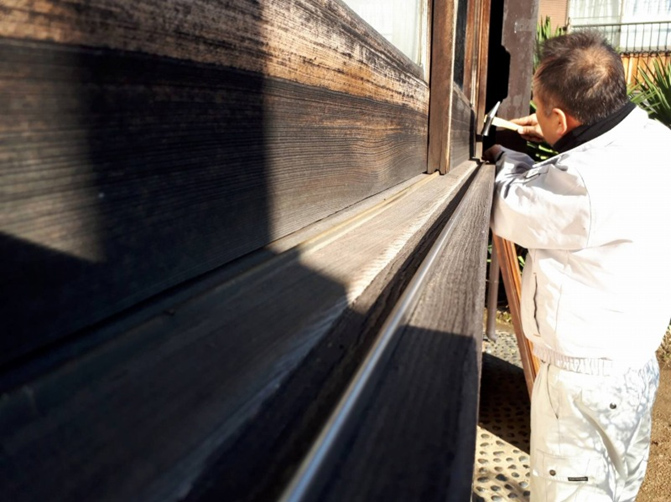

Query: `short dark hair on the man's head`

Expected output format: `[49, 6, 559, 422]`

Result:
[534, 31, 628, 125]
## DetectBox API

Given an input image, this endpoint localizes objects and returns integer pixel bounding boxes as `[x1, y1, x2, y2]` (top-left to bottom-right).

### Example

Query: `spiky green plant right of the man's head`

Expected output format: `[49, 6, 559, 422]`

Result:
[629, 59, 671, 127]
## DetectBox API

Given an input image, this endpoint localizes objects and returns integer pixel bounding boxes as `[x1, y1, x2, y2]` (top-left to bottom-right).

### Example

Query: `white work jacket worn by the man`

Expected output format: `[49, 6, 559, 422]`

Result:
[492, 108, 671, 373]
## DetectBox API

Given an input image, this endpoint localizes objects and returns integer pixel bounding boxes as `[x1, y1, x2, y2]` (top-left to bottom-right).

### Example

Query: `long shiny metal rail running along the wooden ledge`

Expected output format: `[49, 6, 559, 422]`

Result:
[279, 164, 483, 502]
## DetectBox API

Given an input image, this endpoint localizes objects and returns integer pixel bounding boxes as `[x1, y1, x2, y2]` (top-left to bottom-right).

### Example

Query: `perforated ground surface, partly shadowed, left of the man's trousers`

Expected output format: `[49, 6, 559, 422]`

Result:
[473, 331, 530, 502]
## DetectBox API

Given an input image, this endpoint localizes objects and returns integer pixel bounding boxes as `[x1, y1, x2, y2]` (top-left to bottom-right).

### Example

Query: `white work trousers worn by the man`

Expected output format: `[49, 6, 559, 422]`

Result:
[530, 358, 659, 502]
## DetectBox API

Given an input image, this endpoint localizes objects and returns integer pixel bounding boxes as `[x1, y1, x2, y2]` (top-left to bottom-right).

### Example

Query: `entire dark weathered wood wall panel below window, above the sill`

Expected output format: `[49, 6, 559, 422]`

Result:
[0, 0, 428, 364]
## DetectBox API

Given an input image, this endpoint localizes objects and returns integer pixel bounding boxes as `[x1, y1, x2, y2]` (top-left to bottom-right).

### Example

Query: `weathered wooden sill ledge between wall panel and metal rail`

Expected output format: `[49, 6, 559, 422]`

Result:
[0, 165, 472, 502]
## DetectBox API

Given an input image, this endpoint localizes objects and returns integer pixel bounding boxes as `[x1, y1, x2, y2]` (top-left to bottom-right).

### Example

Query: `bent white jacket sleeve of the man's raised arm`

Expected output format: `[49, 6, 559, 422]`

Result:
[491, 150, 590, 250]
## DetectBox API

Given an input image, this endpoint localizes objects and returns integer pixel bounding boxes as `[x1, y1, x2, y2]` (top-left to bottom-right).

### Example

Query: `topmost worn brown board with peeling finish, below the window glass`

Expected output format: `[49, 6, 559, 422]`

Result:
[0, 0, 428, 111]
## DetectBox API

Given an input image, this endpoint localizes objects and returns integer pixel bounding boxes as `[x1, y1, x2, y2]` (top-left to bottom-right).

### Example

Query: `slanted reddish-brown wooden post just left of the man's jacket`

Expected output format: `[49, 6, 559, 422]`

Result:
[492, 235, 540, 397]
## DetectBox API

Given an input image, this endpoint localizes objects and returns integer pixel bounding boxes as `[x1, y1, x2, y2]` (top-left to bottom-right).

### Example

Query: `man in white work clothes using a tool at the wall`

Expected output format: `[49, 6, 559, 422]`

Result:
[485, 32, 671, 502]
